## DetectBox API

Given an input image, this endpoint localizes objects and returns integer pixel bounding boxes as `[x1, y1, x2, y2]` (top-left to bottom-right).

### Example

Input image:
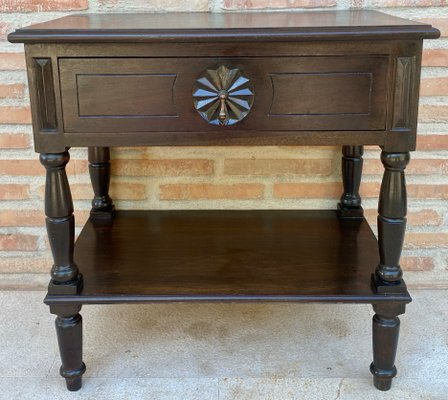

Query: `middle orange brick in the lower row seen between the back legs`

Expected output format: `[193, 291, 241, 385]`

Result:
[160, 183, 264, 200]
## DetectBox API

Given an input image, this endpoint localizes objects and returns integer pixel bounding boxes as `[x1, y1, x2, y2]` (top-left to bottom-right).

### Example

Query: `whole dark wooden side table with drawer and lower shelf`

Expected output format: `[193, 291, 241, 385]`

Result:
[9, 11, 439, 390]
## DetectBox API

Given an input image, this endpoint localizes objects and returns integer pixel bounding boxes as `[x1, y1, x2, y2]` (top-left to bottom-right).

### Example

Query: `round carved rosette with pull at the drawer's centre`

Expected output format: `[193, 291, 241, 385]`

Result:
[193, 65, 254, 125]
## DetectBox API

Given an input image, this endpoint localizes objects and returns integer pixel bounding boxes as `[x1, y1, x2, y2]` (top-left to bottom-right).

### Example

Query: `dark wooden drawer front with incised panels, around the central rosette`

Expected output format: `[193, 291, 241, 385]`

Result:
[59, 55, 389, 133]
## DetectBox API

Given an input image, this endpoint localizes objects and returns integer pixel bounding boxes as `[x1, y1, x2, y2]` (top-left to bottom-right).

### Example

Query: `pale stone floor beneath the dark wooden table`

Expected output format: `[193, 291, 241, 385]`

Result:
[0, 290, 448, 400]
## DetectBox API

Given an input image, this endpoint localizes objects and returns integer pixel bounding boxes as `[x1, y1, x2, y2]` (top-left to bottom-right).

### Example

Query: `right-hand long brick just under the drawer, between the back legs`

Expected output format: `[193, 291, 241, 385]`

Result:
[224, 159, 332, 176]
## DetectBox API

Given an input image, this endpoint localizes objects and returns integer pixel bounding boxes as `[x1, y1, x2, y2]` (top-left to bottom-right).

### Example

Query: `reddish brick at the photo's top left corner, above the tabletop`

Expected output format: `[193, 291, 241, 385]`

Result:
[0, 0, 89, 13]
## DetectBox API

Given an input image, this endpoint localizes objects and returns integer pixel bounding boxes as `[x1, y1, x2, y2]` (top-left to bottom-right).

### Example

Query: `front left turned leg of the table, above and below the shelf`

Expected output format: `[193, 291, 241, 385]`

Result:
[40, 151, 85, 390]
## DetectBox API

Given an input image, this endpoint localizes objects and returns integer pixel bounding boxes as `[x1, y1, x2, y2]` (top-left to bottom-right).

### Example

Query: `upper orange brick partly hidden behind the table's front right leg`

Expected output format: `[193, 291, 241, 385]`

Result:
[363, 159, 448, 175]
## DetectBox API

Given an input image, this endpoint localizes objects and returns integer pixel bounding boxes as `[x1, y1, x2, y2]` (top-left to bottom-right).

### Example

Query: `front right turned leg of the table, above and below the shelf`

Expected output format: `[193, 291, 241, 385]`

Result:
[370, 151, 409, 390]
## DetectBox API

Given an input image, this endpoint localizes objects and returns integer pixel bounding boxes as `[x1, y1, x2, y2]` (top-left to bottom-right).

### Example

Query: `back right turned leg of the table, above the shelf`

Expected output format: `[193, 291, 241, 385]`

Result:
[338, 146, 364, 218]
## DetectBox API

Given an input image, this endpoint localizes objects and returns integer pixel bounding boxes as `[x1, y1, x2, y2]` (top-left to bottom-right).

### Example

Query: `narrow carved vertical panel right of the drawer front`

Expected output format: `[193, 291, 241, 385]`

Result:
[392, 57, 416, 129]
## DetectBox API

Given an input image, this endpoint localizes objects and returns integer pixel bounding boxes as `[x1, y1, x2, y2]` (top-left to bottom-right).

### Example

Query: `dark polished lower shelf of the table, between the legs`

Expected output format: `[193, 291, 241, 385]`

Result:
[45, 210, 411, 304]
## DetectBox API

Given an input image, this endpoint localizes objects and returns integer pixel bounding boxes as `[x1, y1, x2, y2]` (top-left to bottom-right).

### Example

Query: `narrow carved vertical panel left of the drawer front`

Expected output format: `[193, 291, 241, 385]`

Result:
[33, 58, 57, 131]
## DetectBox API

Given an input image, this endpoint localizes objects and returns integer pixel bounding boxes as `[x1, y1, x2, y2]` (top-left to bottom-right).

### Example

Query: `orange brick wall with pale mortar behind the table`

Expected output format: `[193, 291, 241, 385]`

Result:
[0, 0, 448, 287]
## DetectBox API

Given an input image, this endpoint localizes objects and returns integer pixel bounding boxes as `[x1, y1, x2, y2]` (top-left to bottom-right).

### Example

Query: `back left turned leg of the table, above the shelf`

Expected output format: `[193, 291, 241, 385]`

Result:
[89, 147, 114, 220]
